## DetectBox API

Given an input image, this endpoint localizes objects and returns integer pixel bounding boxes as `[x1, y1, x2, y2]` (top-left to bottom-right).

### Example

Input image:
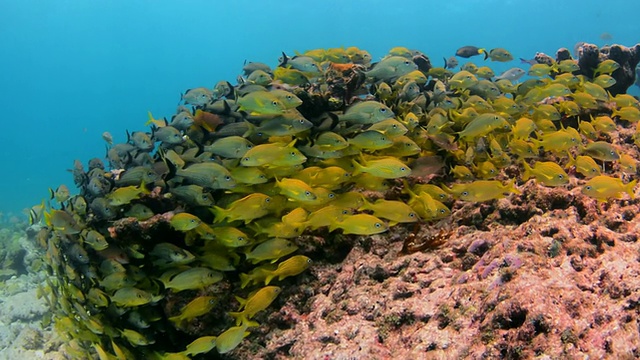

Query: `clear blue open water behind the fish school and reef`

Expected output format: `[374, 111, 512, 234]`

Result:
[0, 0, 640, 217]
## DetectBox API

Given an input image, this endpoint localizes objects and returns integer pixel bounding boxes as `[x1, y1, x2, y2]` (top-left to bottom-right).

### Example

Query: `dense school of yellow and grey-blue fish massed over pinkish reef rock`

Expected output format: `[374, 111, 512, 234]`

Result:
[30, 44, 640, 359]
